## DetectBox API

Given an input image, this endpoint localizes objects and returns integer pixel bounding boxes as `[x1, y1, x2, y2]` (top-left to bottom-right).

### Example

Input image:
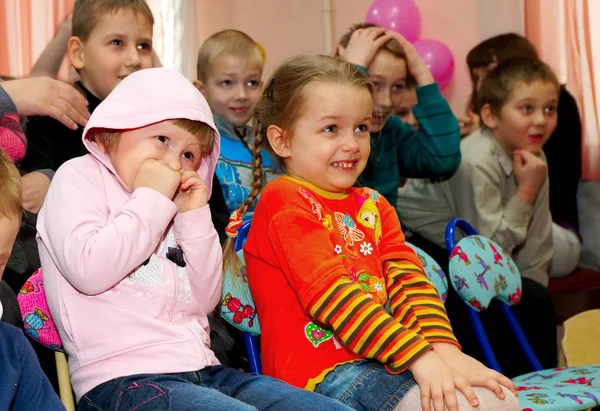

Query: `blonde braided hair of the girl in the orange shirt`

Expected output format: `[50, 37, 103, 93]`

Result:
[223, 56, 373, 278]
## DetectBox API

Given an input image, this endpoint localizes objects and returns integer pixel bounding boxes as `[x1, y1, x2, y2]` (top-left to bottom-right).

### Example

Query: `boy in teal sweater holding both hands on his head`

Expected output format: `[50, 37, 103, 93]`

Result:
[337, 24, 460, 216]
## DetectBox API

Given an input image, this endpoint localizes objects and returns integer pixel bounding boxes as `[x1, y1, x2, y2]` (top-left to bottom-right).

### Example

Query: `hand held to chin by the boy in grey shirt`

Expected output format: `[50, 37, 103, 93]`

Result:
[513, 150, 548, 205]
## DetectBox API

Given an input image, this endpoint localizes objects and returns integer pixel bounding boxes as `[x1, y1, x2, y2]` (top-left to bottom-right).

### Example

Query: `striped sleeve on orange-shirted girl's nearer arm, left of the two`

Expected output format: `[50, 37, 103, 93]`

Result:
[308, 278, 432, 374]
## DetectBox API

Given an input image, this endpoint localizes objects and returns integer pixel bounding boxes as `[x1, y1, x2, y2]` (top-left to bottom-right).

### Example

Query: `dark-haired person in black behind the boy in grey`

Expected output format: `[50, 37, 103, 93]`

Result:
[461, 33, 580, 277]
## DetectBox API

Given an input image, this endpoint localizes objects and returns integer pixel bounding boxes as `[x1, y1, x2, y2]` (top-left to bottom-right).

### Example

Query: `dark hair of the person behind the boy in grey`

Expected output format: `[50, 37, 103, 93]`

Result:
[467, 33, 539, 111]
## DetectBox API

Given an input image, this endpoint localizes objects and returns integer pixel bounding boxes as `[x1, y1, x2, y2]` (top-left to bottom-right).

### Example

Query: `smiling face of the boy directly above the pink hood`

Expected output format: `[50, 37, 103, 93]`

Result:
[69, 9, 152, 100]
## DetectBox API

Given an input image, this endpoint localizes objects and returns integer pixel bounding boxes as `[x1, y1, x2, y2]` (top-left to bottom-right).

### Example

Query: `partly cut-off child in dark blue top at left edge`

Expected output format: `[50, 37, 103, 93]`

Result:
[0, 149, 64, 410]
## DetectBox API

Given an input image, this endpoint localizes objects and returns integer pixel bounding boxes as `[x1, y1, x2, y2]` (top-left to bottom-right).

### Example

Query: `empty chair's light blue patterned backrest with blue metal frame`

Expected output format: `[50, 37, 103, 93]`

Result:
[446, 218, 542, 372]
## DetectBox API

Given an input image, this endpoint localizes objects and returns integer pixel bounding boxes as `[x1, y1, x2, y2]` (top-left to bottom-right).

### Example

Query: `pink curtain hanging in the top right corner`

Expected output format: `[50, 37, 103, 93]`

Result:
[525, 0, 600, 180]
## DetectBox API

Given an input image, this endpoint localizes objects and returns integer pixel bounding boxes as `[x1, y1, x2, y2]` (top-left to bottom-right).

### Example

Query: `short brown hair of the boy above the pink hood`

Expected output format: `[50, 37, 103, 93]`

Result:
[72, 0, 154, 41]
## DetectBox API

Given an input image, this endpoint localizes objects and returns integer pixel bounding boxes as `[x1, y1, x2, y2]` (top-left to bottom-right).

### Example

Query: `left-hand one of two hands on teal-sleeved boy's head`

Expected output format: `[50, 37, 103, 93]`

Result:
[340, 27, 392, 68]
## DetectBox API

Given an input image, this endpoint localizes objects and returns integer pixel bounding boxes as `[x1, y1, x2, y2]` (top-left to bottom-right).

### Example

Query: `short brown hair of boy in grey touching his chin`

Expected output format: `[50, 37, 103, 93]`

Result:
[476, 58, 560, 115]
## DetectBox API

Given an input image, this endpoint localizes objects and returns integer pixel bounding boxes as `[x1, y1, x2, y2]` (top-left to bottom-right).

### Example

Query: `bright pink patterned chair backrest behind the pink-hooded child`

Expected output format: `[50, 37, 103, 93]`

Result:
[17, 268, 64, 352]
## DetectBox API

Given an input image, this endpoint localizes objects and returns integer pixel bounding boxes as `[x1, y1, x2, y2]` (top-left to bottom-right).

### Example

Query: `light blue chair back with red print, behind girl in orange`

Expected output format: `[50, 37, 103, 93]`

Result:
[218, 221, 260, 335]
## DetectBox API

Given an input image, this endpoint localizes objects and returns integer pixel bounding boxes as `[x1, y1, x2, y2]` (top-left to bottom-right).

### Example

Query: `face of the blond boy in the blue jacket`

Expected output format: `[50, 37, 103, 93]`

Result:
[198, 56, 262, 127]
